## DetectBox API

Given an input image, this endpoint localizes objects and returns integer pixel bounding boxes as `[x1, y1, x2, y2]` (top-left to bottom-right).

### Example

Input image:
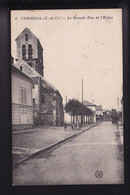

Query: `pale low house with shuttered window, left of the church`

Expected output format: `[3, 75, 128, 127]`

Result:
[11, 65, 34, 130]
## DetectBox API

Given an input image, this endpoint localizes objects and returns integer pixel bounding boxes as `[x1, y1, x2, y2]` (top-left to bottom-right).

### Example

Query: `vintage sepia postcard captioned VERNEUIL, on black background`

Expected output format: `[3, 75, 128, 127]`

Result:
[11, 9, 124, 185]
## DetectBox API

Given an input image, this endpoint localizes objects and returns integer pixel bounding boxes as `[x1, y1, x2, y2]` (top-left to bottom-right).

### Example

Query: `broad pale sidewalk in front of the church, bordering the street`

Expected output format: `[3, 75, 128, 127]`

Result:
[12, 124, 97, 166]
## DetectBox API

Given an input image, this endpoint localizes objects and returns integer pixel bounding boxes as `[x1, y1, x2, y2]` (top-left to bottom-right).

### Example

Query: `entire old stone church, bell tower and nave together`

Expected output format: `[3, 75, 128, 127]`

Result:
[15, 28, 64, 125]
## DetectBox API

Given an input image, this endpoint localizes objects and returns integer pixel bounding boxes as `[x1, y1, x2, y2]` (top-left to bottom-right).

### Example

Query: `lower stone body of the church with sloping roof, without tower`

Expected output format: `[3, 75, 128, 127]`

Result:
[15, 59, 64, 125]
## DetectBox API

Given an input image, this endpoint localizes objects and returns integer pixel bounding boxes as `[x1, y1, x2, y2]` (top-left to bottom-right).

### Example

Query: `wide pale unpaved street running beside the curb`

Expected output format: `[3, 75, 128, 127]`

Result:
[13, 122, 123, 185]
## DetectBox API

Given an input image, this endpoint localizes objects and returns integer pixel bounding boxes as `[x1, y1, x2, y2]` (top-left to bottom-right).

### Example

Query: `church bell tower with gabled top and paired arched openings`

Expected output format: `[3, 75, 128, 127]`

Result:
[15, 28, 44, 76]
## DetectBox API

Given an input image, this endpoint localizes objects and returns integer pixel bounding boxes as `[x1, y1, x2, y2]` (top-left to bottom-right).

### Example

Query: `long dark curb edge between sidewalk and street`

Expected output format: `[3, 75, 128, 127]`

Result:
[12, 123, 99, 168]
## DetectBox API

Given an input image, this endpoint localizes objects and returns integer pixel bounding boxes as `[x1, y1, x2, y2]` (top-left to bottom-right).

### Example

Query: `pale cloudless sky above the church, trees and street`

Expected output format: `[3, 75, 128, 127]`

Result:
[11, 9, 123, 109]
